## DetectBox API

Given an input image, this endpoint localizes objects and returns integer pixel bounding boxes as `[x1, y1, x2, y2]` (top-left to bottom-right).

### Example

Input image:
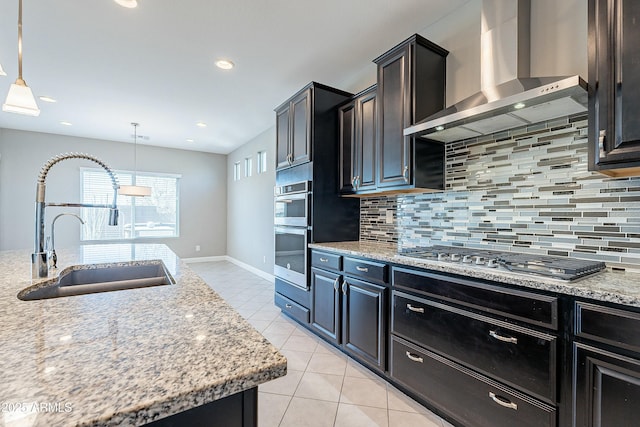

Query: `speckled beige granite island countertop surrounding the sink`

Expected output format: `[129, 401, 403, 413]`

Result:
[0, 244, 287, 427]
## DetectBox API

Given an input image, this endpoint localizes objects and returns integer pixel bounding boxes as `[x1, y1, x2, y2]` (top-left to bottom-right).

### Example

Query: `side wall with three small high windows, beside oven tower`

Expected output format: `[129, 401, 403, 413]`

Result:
[227, 126, 276, 274]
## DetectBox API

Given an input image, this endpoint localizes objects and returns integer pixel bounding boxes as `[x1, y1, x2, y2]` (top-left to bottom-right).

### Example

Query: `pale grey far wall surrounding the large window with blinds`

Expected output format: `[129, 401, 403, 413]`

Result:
[0, 129, 227, 257]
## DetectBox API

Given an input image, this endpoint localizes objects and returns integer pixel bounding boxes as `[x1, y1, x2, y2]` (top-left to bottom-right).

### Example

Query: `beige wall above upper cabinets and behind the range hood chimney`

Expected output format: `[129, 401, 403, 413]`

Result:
[341, 0, 587, 106]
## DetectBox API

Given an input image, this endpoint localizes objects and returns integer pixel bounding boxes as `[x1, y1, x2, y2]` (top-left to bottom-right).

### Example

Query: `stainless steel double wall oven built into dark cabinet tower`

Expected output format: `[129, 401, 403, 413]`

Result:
[273, 181, 311, 290]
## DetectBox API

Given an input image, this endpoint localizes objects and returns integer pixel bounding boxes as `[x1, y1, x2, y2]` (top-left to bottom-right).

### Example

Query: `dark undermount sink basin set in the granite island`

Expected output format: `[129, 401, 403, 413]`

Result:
[18, 263, 175, 301]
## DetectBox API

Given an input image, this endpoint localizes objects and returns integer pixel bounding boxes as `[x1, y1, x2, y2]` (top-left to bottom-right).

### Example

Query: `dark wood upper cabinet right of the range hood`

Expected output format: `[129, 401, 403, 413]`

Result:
[589, 0, 640, 176]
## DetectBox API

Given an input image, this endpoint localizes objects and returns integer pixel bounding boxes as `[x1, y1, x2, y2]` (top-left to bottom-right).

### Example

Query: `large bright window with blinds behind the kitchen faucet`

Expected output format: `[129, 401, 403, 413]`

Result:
[80, 168, 180, 240]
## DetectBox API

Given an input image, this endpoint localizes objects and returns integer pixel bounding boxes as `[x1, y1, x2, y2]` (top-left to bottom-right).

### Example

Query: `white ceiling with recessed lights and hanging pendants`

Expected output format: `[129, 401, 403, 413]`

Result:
[0, 0, 469, 154]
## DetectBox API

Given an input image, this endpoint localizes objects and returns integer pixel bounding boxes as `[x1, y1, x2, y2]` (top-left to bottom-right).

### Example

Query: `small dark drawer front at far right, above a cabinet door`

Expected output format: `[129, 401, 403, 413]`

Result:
[575, 301, 640, 352]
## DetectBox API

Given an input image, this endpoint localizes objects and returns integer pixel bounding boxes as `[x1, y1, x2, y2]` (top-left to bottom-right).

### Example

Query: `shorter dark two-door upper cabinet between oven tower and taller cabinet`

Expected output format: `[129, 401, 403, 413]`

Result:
[339, 85, 378, 194]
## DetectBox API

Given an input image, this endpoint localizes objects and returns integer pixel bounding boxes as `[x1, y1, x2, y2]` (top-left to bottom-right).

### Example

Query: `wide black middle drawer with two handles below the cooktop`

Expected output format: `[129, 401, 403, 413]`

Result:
[391, 291, 557, 403]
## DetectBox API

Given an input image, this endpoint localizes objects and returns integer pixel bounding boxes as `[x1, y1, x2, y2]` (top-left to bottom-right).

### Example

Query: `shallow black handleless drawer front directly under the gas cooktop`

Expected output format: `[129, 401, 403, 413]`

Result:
[392, 267, 558, 330]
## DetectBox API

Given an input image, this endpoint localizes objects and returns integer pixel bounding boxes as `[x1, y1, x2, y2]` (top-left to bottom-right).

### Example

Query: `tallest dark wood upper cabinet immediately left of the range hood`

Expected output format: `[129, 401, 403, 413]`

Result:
[374, 34, 449, 190]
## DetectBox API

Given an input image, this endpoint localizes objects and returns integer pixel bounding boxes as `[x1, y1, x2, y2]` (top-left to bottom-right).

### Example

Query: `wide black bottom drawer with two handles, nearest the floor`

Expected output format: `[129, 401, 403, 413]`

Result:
[391, 337, 556, 427]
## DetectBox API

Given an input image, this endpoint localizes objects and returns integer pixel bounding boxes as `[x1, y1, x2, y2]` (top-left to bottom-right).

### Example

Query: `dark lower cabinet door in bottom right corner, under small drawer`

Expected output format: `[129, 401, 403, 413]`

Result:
[573, 343, 640, 427]
